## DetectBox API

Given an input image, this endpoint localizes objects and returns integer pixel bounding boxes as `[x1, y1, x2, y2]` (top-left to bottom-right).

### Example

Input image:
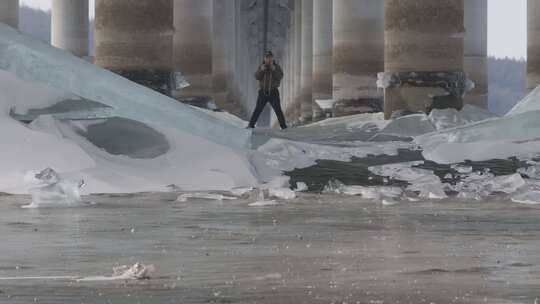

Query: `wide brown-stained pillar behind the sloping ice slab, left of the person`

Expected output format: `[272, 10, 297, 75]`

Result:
[95, 0, 173, 94]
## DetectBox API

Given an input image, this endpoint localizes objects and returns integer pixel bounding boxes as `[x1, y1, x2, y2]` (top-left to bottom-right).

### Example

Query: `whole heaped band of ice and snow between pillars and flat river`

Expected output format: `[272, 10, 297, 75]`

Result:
[0, 25, 540, 206]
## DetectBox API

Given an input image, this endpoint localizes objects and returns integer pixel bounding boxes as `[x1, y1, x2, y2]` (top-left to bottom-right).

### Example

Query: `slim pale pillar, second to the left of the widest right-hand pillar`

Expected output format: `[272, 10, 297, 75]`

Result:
[313, 0, 333, 119]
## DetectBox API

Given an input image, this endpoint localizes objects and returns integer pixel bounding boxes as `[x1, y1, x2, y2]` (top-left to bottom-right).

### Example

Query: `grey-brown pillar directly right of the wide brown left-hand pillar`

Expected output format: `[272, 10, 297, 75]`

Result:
[174, 0, 214, 103]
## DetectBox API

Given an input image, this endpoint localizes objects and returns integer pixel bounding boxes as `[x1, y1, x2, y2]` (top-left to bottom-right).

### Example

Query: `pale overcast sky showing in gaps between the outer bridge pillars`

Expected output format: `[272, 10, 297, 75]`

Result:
[20, 0, 527, 58]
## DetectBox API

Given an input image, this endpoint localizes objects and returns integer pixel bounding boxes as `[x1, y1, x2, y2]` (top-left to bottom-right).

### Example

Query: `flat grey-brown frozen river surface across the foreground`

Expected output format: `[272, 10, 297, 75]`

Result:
[0, 194, 540, 304]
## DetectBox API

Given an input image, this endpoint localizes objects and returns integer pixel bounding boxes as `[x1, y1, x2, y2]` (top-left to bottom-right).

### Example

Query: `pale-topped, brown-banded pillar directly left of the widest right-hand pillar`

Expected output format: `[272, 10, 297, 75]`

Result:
[333, 0, 384, 116]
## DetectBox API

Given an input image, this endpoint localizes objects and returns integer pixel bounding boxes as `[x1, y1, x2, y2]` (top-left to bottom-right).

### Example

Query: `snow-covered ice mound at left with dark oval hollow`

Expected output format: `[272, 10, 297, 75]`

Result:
[0, 25, 259, 194]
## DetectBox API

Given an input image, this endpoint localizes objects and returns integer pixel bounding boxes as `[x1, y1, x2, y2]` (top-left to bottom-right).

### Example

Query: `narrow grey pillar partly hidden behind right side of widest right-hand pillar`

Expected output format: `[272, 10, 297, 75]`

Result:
[463, 0, 488, 109]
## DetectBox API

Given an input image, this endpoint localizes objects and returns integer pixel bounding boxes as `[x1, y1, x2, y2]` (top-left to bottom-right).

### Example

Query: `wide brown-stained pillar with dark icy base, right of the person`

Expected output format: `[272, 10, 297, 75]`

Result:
[382, 0, 466, 118]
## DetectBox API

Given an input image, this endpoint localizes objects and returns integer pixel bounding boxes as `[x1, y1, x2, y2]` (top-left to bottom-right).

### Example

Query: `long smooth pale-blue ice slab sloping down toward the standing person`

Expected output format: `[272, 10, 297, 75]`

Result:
[0, 24, 251, 148]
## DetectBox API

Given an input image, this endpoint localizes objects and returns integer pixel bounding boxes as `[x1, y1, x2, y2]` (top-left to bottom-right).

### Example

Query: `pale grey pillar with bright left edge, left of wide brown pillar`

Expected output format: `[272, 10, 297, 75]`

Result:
[51, 0, 88, 57]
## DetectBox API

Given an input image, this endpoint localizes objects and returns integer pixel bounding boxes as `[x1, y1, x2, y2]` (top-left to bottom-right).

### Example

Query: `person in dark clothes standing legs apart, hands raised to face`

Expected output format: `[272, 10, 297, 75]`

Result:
[248, 51, 287, 130]
